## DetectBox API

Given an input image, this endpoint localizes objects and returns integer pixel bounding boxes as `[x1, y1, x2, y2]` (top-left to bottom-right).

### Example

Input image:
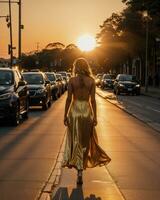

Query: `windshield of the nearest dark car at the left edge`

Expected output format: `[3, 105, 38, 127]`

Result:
[0, 70, 13, 85]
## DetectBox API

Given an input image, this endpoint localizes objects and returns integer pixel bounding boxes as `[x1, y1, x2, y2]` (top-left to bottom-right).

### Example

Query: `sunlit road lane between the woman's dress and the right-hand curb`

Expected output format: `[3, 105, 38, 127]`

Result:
[95, 95, 160, 200]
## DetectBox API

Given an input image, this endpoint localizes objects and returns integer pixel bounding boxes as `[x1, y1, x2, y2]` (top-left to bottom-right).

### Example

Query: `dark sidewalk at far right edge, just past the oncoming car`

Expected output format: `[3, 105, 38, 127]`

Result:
[141, 87, 160, 99]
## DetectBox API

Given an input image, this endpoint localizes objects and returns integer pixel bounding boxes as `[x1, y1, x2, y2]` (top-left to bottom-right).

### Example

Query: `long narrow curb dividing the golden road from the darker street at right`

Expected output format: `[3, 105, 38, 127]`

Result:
[96, 92, 160, 133]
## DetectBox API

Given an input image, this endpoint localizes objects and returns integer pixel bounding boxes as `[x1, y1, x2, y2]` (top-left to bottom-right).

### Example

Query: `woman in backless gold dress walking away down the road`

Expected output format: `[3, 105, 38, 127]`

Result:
[63, 58, 111, 184]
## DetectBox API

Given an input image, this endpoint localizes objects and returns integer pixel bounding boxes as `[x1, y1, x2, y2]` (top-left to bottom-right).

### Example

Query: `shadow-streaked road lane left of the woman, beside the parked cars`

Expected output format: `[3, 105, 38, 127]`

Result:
[0, 96, 65, 200]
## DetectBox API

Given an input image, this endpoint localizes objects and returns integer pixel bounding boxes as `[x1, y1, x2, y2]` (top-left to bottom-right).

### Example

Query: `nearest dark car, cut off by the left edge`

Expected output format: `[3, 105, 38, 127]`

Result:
[0, 68, 28, 125]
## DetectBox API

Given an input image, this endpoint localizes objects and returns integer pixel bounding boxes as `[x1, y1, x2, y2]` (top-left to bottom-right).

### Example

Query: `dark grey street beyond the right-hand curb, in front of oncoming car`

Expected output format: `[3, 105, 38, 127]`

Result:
[97, 88, 160, 132]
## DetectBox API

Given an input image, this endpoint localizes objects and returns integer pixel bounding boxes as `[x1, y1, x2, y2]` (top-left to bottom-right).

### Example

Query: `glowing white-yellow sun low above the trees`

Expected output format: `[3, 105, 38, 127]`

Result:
[77, 34, 96, 51]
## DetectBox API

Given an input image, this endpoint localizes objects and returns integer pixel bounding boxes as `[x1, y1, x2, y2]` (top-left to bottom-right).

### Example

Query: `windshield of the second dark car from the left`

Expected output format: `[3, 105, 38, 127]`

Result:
[23, 73, 44, 85]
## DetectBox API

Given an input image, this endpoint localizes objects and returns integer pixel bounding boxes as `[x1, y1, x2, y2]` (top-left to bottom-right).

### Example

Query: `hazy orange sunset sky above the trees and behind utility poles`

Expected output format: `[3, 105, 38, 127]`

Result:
[0, 0, 124, 57]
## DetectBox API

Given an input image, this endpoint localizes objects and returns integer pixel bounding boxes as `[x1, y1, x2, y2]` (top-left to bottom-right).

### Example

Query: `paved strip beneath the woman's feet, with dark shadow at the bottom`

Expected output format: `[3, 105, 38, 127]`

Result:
[52, 167, 124, 200]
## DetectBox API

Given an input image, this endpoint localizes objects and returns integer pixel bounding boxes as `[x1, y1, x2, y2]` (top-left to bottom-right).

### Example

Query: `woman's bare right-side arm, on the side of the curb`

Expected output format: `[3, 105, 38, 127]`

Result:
[91, 81, 97, 126]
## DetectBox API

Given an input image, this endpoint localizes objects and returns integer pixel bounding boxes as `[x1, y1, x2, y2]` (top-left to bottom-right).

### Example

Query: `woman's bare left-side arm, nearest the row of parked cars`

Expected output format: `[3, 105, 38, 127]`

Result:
[64, 79, 73, 126]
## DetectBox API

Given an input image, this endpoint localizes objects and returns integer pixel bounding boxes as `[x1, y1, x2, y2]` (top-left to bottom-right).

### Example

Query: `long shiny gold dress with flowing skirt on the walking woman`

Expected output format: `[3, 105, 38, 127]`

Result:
[63, 76, 111, 170]
